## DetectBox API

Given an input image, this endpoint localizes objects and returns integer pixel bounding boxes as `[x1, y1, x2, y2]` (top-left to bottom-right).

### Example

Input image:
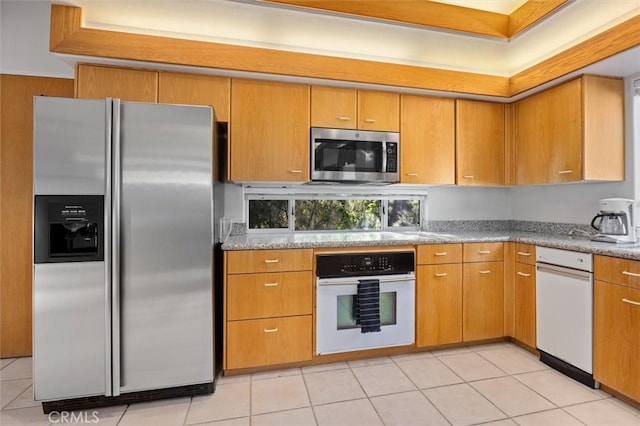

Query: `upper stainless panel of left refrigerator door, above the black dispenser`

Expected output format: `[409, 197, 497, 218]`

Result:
[33, 96, 110, 195]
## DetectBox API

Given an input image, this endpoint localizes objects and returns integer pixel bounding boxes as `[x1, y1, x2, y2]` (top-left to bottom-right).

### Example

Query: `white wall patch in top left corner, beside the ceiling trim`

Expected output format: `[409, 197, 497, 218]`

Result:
[0, 0, 74, 78]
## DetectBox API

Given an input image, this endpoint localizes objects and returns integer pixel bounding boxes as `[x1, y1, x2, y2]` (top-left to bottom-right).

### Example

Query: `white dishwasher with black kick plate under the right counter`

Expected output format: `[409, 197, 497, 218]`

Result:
[536, 247, 599, 388]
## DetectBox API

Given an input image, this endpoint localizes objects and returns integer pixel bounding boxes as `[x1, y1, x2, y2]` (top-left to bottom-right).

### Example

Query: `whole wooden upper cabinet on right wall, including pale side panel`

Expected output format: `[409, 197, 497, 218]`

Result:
[515, 75, 624, 185]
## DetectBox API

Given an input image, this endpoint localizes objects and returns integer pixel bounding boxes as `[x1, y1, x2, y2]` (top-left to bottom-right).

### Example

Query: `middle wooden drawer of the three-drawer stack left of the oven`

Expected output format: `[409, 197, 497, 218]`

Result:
[227, 271, 313, 321]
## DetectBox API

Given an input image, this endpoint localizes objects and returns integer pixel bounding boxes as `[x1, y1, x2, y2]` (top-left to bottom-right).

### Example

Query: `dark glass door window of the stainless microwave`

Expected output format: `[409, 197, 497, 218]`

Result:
[314, 139, 383, 173]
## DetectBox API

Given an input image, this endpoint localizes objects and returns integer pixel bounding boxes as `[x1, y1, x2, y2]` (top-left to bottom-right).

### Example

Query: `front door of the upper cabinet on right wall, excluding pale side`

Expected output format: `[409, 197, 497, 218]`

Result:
[515, 79, 582, 185]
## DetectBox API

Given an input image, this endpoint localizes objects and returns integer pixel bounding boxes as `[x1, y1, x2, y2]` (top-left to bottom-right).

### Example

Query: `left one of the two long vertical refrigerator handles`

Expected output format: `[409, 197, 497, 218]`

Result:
[103, 98, 113, 396]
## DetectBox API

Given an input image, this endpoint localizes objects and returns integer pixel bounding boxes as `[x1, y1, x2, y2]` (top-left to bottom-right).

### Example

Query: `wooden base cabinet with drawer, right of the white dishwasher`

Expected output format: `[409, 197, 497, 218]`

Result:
[593, 256, 640, 401]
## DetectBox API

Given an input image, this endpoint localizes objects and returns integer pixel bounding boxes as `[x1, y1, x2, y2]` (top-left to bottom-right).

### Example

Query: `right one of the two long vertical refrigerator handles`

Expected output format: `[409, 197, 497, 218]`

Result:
[111, 99, 124, 396]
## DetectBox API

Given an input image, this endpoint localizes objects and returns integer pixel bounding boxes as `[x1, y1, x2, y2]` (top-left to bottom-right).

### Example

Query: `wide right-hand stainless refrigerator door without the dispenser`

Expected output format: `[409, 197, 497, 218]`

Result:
[114, 103, 213, 393]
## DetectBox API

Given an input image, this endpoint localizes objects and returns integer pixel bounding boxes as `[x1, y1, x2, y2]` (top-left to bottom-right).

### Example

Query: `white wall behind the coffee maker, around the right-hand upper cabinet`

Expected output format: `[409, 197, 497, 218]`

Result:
[510, 75, 640, 224]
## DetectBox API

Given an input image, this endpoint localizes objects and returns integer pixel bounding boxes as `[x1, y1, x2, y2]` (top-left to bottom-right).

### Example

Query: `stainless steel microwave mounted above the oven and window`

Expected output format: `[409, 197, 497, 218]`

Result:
[311, 127, 400, 183]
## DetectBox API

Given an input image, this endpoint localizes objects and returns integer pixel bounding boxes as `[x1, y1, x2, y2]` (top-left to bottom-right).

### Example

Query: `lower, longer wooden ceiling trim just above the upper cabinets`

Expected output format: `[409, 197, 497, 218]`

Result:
[50, 5, 640, 98]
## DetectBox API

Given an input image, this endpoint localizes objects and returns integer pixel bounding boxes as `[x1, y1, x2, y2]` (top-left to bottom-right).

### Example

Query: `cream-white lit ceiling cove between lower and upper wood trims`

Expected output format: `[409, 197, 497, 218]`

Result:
[64, 0, 640, 80]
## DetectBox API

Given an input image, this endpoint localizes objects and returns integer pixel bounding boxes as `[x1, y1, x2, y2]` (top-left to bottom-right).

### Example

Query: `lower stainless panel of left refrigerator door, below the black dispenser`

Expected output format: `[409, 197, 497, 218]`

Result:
[33, 262, 107, 401]
